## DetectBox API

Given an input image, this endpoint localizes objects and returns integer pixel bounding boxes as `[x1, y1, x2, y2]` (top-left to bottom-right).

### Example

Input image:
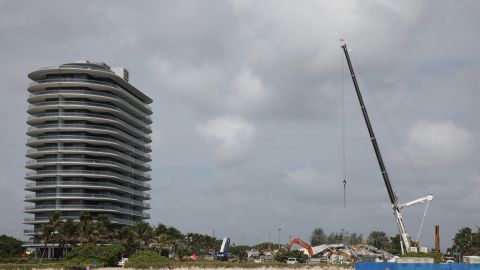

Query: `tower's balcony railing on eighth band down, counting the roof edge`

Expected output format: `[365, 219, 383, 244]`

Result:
[27, 146, 151, 171]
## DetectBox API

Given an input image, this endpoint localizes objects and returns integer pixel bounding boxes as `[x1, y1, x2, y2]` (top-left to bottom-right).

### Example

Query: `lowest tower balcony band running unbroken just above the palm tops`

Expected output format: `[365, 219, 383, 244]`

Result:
[25, 204, 150, 218]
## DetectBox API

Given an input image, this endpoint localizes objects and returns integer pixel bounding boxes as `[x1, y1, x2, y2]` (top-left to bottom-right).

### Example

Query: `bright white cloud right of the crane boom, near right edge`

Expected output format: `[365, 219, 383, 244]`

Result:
[405, 121, 475, 167]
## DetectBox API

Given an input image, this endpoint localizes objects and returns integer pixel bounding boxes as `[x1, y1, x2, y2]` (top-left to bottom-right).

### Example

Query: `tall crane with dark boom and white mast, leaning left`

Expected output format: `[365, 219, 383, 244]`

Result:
[340, 40, 433, 254]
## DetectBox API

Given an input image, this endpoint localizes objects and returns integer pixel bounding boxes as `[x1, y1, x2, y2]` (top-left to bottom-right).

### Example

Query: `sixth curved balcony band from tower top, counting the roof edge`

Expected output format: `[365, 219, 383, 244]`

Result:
[27, 124, 151, 150]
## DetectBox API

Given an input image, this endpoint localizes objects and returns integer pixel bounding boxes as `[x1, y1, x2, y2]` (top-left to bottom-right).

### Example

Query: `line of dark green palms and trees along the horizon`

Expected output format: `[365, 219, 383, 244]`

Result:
[0, 215, 480, 259]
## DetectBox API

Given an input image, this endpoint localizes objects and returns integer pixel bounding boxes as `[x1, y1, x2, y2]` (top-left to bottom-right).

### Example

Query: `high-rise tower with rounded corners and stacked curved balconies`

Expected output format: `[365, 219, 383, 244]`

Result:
[24, 61, 152, 255]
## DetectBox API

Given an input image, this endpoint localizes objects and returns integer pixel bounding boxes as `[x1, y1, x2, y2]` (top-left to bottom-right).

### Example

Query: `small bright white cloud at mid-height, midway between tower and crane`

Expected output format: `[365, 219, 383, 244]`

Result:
[196, 116, 255, 165]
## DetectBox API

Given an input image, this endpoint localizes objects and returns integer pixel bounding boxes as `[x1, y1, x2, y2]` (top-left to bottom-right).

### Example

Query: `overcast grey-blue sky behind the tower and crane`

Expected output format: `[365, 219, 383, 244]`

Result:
[0, 0, 480, 252]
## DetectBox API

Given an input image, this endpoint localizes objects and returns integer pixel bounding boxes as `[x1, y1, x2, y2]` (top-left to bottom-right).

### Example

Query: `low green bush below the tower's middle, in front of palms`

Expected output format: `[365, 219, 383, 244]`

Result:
[67, 244, 125, 266]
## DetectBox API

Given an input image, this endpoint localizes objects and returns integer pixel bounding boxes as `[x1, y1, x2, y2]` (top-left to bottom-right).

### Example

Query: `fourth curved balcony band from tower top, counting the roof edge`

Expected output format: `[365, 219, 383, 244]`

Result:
[27, 100, 152, 128]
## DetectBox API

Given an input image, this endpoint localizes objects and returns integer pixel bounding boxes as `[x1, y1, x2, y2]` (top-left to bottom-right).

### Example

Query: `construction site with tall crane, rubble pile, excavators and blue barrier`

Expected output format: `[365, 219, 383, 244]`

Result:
[209, 40, 480, 269]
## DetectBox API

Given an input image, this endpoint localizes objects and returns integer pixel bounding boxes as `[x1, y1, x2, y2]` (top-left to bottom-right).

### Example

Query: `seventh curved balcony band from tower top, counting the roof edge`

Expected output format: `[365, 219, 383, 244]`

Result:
[27, 135, 152, 158]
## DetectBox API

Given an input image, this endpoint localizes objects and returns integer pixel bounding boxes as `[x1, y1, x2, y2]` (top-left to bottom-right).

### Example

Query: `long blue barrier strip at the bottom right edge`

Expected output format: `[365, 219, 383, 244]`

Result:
[355, 262, 480, 270]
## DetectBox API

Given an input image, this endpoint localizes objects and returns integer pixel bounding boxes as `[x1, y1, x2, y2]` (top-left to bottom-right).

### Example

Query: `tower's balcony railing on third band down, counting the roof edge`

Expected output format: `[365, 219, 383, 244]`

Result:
[29, 89, 152, 124]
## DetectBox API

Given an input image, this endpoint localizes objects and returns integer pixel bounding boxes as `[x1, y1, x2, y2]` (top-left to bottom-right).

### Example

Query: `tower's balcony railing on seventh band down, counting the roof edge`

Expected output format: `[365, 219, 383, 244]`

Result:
[27, 135, 152, 158]
